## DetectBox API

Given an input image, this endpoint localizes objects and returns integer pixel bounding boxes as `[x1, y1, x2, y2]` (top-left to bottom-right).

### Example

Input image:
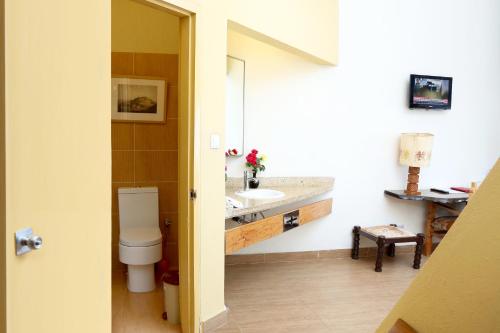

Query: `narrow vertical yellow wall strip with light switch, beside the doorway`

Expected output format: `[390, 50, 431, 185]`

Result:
[195, 1, 227, 321]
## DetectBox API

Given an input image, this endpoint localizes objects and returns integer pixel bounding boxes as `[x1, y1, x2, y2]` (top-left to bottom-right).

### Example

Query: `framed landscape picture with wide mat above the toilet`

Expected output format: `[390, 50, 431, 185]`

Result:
[111, 77, 167, 122]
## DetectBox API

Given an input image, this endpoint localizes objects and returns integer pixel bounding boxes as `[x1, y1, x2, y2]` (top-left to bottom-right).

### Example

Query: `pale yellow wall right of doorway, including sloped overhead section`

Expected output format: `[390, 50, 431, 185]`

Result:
[167, 0, 337, 321]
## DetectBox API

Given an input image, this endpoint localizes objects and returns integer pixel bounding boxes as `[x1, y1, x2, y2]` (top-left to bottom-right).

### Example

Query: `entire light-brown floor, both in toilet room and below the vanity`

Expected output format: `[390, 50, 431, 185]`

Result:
[113, 254, 425, 333]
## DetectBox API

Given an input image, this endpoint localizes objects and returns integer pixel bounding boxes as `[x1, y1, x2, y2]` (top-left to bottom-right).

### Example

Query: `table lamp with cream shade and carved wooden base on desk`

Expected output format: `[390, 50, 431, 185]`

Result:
[399, 133, 434, 195]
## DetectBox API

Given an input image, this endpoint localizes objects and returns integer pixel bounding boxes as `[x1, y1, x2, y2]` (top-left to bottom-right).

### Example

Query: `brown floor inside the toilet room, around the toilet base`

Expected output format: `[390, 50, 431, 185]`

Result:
[112, 271, 181, 333]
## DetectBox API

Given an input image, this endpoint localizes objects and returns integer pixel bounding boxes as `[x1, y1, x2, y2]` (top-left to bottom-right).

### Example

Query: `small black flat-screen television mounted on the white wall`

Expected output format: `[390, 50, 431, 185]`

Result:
[410, 74, 453, 110]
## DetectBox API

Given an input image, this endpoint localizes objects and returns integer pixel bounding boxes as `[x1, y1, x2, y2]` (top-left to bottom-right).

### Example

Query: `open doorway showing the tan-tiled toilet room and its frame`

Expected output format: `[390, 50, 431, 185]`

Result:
[111, 0, 198, 333]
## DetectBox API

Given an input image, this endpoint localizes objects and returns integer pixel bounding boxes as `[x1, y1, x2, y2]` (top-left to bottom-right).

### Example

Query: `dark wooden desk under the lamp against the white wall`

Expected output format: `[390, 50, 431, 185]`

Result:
[384, 190, 469, 256]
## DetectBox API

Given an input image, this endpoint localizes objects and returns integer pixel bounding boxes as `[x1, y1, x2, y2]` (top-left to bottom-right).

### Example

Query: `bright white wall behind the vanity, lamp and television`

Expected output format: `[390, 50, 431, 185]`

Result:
[228, 0, 500, 253]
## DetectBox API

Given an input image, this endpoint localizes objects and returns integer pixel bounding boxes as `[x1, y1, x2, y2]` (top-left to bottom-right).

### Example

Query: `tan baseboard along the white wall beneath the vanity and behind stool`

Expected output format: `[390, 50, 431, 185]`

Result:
[226, 245, 415, 265]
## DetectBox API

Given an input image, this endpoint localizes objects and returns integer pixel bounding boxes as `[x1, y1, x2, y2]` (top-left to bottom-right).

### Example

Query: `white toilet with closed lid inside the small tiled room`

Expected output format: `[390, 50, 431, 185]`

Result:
[118, 187, 162, 293]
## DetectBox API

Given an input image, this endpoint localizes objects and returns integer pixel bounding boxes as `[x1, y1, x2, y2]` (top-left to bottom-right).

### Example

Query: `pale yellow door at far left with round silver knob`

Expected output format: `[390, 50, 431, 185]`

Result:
[2, 0, 111, 333]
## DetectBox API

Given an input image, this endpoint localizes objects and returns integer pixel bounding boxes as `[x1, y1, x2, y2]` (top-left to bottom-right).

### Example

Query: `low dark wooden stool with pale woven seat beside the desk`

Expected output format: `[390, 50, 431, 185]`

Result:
[351, 224, 424, 272]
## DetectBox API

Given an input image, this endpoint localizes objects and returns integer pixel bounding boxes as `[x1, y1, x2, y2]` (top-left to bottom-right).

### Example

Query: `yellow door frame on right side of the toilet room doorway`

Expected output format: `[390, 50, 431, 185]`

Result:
[142, 0, 200, 333]
